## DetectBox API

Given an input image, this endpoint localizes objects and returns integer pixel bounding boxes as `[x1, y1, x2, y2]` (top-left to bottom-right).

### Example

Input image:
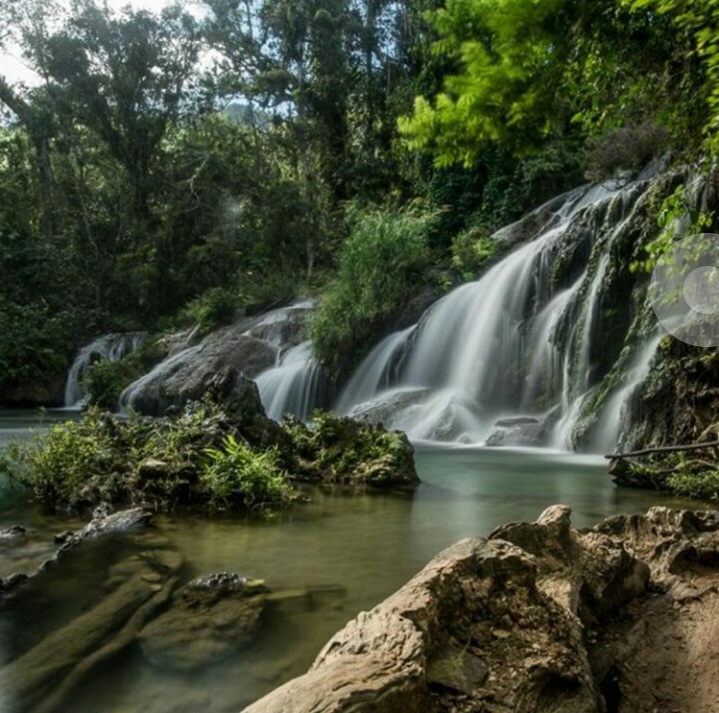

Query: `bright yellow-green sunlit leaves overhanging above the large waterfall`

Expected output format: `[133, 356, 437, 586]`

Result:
[399, 0, 571, 166]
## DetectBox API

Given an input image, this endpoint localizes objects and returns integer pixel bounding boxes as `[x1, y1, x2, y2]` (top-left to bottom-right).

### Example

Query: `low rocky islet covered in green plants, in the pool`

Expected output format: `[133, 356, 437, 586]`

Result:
[0, 400, 418, 509]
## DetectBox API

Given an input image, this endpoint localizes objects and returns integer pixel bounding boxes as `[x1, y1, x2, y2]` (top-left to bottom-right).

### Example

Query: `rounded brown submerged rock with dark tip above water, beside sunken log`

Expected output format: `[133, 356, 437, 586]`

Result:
[140, 572, 269, 671]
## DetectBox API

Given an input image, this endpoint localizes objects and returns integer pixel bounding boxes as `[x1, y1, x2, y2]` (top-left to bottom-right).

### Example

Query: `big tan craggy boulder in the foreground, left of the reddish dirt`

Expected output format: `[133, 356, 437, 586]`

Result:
[240, 528, 602, 713]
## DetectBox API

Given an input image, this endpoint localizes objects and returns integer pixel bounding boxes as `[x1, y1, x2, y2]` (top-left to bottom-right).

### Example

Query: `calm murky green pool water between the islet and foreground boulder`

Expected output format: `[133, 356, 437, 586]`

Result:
[0, 414, 696, 713]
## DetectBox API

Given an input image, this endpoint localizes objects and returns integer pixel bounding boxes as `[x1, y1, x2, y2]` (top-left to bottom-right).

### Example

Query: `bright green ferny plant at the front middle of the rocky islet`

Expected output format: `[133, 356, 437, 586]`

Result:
[200, 434, 292, 507]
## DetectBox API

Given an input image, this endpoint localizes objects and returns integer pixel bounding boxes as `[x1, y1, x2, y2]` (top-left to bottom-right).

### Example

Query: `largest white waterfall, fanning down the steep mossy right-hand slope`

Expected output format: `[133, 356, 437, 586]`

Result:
[336, 181, 650, 447]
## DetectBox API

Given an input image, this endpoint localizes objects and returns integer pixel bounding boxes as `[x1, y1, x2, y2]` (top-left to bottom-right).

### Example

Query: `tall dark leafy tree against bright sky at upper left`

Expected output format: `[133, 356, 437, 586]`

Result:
[24, 0, 200, 221]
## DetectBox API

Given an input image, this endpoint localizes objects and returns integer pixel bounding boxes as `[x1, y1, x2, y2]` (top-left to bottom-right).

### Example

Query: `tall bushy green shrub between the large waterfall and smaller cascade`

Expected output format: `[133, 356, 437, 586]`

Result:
[310, 203, 434, 368]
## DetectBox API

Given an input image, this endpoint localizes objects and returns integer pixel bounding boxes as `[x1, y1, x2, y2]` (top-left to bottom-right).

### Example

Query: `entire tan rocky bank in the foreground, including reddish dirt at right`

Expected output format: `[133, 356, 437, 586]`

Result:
[244, 505, 719, 713]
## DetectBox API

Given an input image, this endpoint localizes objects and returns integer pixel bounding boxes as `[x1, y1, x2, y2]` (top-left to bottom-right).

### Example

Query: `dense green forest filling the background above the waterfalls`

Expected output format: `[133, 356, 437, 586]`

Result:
[0, 0, 719, 394]
